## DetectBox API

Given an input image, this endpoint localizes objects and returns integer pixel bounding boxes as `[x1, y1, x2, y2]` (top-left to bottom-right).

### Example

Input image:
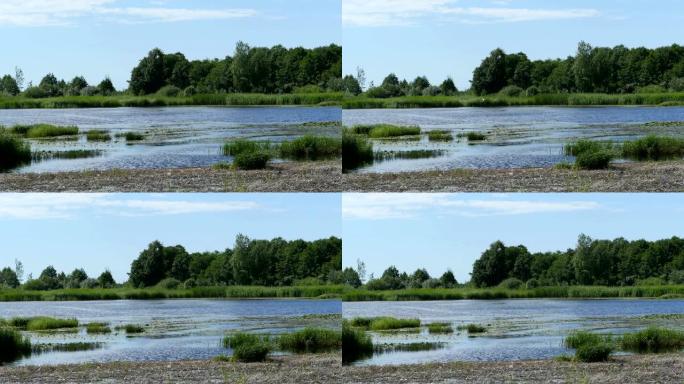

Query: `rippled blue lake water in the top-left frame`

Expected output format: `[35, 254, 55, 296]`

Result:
[0, 107, 342, 172]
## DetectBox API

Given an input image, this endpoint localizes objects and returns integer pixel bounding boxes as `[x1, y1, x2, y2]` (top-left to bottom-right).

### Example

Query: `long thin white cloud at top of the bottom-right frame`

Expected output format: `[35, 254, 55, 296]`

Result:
[342, 193, 601, 220]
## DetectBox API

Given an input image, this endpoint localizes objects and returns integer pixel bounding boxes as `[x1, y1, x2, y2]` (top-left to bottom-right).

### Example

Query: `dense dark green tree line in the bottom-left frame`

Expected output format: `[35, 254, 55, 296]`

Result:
[0, 235, 342, 290]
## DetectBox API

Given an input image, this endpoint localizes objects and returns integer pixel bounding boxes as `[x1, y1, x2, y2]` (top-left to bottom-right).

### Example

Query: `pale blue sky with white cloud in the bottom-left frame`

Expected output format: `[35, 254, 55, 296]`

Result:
[0, 193, 341, 282]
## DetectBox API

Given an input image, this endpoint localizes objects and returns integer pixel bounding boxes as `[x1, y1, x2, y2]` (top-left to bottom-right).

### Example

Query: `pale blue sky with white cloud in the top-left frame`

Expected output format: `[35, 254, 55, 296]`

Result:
[0, 0, 342, 88]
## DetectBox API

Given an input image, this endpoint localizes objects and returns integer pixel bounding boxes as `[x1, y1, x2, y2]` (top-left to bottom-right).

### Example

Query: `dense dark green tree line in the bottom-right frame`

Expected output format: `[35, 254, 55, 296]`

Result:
[352, 235, 684, 290]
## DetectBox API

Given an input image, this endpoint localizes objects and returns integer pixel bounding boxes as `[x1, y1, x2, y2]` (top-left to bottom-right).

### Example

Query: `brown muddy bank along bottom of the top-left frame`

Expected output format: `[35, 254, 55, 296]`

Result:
[0, 160, 342, 192]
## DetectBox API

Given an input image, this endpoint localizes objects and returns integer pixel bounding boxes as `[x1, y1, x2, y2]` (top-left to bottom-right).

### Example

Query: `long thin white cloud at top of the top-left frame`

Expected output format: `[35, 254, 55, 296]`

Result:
[0, 0, 257, 27]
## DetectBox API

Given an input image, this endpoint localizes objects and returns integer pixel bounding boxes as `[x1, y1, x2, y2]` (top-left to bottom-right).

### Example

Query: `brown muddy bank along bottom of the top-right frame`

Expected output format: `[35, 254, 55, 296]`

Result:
[342, 161, 684, 192]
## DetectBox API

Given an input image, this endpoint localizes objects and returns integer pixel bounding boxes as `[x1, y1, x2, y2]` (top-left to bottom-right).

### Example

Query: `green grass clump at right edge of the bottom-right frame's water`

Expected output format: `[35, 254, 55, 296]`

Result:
[620, 327, 684, 353]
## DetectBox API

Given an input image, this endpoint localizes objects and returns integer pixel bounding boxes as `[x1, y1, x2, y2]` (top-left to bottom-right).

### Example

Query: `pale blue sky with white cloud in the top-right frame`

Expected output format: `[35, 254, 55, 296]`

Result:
[342, 0, 684, 89]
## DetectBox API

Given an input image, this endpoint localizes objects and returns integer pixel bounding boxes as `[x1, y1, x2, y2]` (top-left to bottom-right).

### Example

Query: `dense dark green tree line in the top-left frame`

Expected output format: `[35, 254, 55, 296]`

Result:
[0, 42, 343, 98]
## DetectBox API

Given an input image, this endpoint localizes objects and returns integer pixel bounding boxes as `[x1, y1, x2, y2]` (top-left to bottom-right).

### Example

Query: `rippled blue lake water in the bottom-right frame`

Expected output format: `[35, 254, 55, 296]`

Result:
[342, 299, 684, 365]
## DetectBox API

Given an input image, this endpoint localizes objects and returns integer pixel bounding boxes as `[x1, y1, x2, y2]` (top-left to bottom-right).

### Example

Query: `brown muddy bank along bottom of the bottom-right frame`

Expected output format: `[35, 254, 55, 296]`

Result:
[343, 354, 684, 384]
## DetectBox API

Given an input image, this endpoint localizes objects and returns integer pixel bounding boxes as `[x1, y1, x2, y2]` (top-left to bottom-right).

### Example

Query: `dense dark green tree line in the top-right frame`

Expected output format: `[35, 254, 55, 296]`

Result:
[352, 42, 684, 98]
